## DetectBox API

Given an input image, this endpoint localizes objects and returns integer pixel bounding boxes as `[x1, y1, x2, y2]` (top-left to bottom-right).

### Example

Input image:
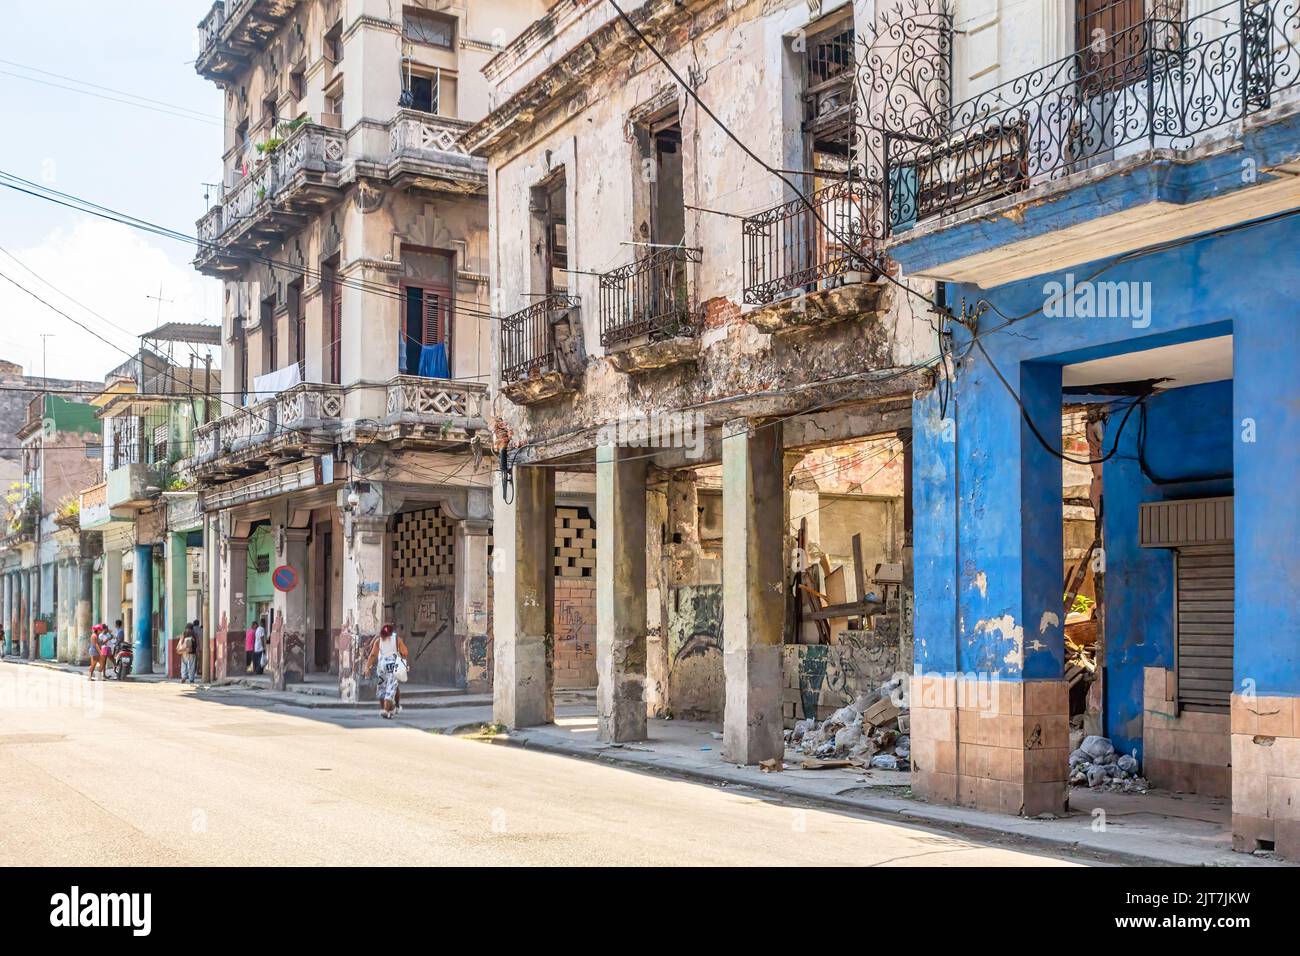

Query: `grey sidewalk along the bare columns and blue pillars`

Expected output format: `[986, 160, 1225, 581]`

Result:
[489, 710, 1286, 866]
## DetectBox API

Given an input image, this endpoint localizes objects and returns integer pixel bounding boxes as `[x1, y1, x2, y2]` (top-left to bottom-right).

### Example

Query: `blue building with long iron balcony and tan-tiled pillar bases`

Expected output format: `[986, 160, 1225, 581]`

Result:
[883, 0, 1300, 858]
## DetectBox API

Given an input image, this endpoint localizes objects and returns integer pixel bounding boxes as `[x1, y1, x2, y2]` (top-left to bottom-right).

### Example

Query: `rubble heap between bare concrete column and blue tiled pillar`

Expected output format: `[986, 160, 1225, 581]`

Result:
[785, 680, 911, 770]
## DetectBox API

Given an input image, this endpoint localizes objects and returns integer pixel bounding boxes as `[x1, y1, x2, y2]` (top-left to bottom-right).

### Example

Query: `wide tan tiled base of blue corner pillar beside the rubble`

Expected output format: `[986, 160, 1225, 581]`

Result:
[910, 675, 1070, 817]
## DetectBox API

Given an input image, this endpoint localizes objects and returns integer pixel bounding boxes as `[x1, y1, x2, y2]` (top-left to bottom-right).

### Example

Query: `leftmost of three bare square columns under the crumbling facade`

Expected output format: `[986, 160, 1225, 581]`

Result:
[493, 466, 555, 727]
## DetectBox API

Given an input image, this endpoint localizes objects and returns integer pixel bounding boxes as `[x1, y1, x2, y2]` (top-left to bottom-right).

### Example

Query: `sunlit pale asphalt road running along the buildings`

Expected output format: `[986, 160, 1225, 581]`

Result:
[0, 662, 1067, 866]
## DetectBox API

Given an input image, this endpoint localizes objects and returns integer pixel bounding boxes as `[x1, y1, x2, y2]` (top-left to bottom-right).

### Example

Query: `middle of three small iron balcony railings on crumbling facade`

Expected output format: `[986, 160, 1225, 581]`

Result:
[599, 246, 699, 349]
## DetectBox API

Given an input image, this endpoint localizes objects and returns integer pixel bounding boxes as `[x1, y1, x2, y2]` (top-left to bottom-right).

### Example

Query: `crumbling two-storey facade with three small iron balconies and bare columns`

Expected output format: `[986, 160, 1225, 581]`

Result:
[473, 0, 936, 762]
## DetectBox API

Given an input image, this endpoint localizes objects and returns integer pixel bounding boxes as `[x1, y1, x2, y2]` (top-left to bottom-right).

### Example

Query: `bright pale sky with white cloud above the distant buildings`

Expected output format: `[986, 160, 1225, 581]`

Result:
[0, 0, 222, 380]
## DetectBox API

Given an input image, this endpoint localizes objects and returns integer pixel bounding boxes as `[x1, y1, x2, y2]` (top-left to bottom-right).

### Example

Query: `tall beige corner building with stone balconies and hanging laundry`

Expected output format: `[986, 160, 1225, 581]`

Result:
[189, 0, 541, 697]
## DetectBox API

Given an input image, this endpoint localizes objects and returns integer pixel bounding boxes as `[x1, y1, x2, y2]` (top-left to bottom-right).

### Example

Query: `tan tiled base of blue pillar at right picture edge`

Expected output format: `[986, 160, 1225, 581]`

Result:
[1231, 693, 1300, 861]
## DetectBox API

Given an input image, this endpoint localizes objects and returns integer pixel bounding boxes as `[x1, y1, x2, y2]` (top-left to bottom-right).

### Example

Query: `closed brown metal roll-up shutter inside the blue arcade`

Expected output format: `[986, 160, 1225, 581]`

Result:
[1174, 545, 1232, 713]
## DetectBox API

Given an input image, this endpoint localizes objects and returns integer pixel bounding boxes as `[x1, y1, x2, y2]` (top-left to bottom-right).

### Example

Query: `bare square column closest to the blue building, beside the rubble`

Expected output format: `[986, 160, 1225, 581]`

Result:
[723, 419, 785, 763]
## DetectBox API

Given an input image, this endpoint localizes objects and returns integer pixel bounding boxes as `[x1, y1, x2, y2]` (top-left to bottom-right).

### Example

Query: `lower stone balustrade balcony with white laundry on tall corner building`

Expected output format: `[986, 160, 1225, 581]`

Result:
[181, 376, 488, 479]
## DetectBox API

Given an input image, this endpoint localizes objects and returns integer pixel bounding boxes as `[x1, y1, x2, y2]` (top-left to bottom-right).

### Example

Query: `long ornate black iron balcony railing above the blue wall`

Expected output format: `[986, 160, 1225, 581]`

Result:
[884, 0, 1300, 232]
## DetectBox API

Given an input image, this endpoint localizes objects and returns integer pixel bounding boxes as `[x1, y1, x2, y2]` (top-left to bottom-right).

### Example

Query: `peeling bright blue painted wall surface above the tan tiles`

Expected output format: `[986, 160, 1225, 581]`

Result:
[914, 217, 1300, 728]
